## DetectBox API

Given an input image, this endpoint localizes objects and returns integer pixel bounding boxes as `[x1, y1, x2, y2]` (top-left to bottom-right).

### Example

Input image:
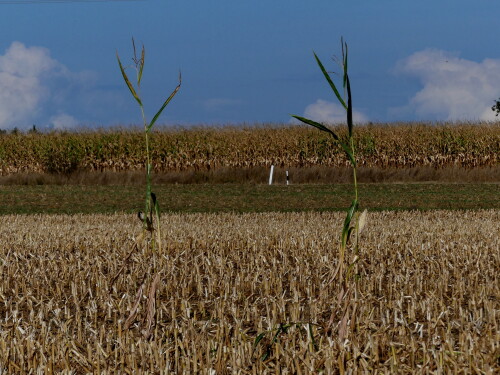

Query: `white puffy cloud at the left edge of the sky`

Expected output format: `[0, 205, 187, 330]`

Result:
[0, 42, 84, 129]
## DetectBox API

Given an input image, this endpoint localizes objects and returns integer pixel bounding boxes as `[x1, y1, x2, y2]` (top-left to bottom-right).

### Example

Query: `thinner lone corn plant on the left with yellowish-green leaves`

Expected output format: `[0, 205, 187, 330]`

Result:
[116, 38, 181, 250]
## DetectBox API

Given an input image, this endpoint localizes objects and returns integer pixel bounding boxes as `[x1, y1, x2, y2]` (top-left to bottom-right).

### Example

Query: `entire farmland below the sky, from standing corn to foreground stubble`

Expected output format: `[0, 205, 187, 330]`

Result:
[0, 123, 500, 375]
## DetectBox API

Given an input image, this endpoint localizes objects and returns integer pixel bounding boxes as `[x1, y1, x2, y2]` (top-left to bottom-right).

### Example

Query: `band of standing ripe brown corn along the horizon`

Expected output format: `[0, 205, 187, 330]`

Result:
[0, 123, 500, 175]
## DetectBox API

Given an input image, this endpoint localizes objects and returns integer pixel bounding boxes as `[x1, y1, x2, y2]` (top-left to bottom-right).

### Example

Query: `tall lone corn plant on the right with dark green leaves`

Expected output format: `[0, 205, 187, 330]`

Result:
[292, 39, 366, 283]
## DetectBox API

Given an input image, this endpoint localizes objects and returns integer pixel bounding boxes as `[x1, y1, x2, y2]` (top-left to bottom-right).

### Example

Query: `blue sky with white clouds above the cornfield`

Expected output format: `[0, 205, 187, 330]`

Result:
[0, 0, 500, 128]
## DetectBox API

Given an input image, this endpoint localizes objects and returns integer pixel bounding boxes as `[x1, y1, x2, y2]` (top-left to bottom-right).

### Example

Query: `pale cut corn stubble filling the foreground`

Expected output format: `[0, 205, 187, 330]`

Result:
[0, 210, 500, 374]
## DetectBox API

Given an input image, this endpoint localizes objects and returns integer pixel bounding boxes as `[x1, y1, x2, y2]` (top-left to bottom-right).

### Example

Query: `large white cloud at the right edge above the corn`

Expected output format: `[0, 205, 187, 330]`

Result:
[392, 49, 500, 121]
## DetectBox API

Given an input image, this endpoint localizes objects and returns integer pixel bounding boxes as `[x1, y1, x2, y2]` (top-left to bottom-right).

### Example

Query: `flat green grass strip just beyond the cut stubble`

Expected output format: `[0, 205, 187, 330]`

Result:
[0, 183, 500, 215]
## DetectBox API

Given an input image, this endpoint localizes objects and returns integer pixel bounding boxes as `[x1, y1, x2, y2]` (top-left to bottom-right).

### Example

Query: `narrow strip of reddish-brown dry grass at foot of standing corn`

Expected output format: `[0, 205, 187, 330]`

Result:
[0, 164, 500, 186]
